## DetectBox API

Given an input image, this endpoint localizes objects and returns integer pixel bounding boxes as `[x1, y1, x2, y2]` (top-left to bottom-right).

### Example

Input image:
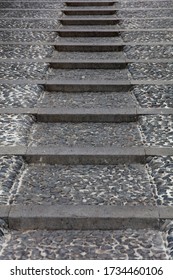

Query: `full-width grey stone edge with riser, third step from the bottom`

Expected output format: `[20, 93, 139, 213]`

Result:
[0, 106, 173, 122]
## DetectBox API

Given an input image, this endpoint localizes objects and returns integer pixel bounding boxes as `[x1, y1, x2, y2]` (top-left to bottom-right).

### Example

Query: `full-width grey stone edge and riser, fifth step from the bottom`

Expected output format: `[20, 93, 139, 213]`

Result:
[0, 58, 173, 64]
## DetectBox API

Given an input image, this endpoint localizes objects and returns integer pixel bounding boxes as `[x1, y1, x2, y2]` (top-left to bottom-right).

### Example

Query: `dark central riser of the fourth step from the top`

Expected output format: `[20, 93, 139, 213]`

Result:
[58, 30, 119, 38]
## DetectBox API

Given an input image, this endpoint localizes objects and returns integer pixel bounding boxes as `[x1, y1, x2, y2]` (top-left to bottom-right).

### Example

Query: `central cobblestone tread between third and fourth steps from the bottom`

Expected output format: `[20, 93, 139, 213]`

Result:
[39, 92, 137, 108]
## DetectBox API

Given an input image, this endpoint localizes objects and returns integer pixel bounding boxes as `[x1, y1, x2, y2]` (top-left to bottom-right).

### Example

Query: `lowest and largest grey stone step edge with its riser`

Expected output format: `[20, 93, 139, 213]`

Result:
[0, 204, 173, 230]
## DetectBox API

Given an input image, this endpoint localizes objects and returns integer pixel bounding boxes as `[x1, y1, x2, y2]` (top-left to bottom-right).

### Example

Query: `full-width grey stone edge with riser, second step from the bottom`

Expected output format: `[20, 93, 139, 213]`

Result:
[0, 145, 173, 165]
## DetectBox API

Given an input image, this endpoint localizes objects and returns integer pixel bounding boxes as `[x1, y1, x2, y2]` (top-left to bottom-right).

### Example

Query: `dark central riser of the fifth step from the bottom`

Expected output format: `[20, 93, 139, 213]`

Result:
[49, 62, 127, 69]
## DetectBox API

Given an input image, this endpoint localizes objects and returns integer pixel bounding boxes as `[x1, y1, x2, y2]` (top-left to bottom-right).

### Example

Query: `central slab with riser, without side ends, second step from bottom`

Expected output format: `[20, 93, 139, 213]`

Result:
[26, 146, 145, 164]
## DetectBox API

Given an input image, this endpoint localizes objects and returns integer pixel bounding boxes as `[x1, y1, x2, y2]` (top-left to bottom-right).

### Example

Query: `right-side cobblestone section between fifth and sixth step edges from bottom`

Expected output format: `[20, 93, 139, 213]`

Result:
[124, 45, 173, 60]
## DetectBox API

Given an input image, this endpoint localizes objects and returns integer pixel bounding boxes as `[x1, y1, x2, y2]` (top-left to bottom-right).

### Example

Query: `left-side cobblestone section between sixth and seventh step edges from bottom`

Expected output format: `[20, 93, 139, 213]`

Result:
[0, 30, 57, 42]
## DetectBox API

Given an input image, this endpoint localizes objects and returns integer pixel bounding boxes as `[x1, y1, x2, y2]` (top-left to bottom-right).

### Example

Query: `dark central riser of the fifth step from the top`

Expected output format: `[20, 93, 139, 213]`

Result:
[55, 45, 124, 52]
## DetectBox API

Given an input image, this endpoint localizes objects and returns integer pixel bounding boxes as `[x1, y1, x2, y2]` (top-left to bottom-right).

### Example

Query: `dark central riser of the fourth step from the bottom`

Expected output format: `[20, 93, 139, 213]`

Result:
[45, 84, 131, 92]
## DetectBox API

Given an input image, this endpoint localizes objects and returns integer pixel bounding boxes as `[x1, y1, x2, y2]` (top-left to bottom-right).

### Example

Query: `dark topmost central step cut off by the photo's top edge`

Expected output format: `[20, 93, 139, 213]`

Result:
[65, 1, 115, 7]
